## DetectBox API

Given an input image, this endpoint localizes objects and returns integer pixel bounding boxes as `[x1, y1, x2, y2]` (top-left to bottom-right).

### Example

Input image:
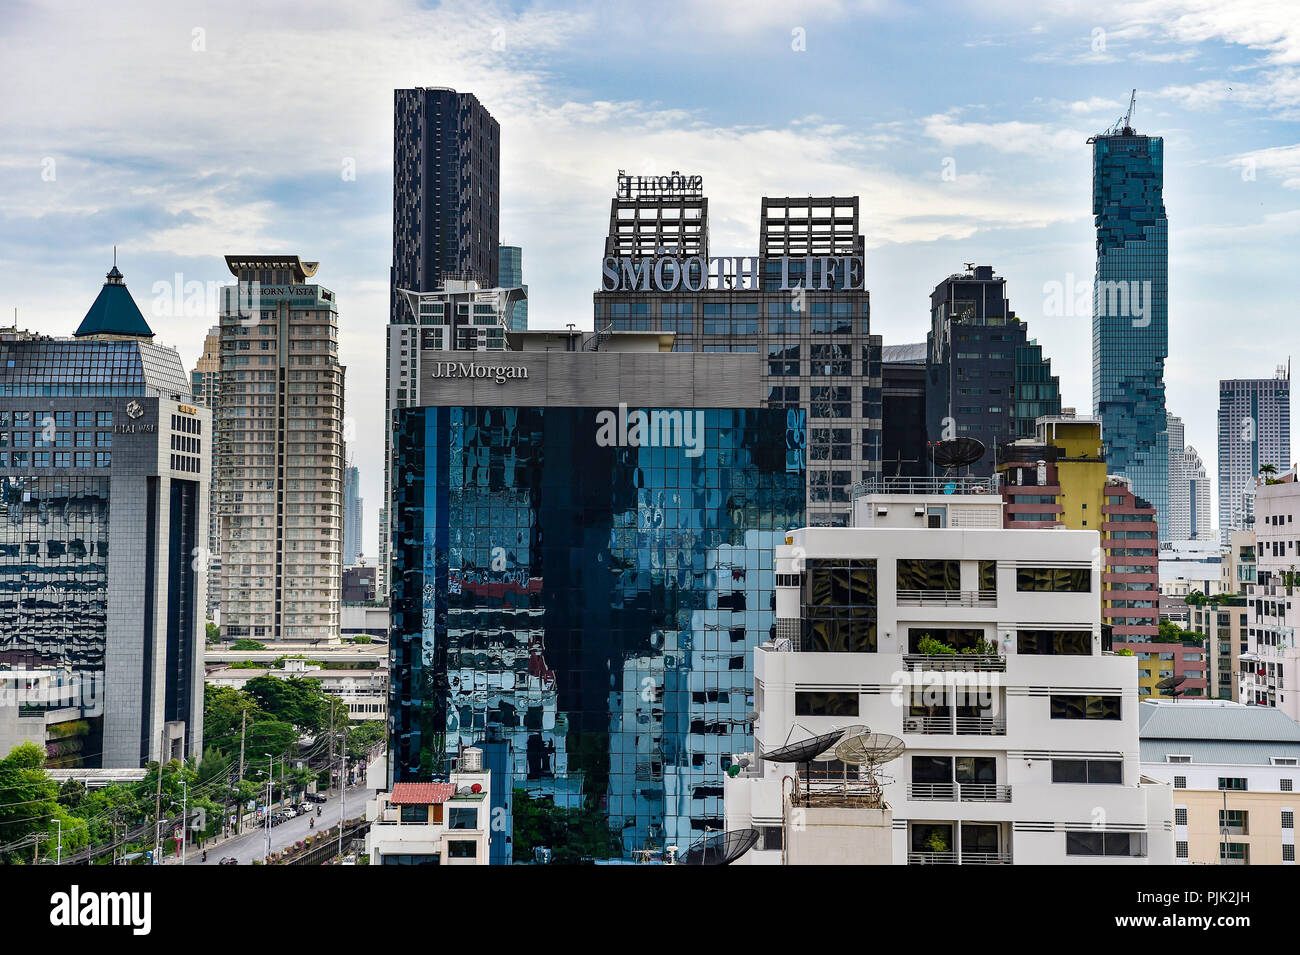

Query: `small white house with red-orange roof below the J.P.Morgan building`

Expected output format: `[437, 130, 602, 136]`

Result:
[365, 764, 493, 865]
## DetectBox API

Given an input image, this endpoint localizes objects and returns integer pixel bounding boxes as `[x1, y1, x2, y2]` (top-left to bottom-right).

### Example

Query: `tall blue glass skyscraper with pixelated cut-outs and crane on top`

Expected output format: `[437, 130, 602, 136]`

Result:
[1088, 111, 1169, 535]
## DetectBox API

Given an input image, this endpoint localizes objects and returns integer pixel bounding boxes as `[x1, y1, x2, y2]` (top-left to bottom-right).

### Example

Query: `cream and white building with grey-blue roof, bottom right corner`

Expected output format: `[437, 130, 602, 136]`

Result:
[1138, 700, 1300, 865]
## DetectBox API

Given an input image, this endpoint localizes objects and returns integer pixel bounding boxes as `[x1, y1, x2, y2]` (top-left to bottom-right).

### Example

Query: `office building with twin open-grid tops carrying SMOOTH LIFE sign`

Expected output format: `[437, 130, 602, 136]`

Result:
[594, 170, 881, 526]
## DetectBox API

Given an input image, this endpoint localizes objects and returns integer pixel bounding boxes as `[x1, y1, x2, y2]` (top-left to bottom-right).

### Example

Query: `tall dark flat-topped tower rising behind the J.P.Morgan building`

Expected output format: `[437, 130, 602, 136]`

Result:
[377, 87, 501, 598]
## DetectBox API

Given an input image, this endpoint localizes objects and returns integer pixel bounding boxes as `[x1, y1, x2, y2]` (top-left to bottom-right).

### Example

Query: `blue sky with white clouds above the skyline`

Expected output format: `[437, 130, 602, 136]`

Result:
[0, 0, 1300, 559]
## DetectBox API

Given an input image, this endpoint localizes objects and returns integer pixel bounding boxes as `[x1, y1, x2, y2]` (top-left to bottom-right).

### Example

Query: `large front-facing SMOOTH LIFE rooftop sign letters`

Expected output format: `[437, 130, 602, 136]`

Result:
[601, 256, 865, 292]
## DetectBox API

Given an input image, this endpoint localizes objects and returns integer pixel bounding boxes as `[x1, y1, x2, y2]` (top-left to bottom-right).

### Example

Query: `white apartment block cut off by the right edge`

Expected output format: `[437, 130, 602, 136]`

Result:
[1238, 472, 1300, 720]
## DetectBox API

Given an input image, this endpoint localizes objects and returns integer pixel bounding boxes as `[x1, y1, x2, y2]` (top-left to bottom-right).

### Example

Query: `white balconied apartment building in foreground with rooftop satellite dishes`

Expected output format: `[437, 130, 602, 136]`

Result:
[724, 478, 1173, 864]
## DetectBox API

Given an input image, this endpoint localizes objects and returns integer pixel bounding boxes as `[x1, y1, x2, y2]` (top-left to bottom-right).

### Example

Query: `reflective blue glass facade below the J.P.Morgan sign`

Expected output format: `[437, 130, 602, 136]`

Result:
[390, 407, 805, 861]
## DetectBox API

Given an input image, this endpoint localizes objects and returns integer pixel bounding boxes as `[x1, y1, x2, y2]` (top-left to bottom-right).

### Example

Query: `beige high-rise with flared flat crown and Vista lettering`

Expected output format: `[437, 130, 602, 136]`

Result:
[216, 255, 345, 641]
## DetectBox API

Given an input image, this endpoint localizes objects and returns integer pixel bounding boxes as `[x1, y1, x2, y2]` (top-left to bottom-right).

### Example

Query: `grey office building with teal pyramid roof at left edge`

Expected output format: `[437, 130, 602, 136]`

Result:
[0, 265, 212, 769]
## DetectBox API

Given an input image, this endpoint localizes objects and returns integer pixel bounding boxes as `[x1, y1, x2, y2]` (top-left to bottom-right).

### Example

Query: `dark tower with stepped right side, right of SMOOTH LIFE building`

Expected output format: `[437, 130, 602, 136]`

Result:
[926, 265, 1061, 474]
